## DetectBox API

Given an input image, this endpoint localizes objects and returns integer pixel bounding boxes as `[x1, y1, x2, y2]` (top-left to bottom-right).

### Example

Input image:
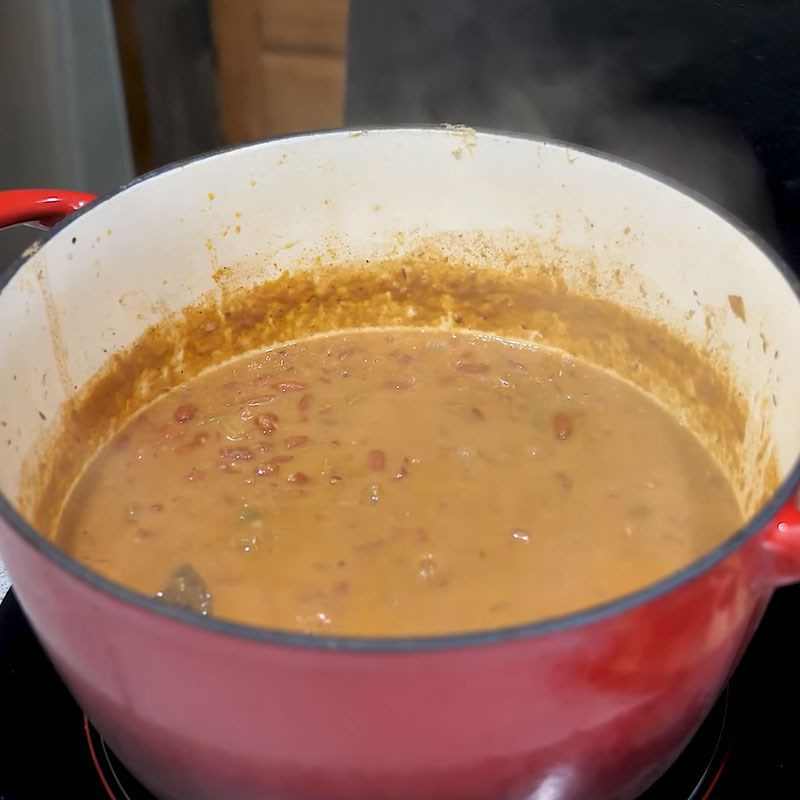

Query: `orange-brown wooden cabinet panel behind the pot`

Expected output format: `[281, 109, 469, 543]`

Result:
[211, 0, 348, 143]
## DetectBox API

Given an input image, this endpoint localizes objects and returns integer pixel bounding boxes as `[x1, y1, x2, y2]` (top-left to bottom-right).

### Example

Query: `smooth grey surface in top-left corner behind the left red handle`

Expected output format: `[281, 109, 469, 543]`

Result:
[0, 0, 133, 269]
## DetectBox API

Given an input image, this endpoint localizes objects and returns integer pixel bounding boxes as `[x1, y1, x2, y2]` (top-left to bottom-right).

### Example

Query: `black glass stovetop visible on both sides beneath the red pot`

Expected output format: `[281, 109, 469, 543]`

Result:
[0, 586, 800, 800]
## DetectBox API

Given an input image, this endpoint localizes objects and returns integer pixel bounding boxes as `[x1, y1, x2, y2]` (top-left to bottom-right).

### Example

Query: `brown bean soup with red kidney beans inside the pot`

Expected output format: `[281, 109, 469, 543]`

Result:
[57, 329, 742, 636]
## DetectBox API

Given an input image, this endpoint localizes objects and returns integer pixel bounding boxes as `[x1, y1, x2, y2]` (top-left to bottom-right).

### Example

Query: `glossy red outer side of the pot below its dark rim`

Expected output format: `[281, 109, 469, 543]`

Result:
[0, 512, 770, 800]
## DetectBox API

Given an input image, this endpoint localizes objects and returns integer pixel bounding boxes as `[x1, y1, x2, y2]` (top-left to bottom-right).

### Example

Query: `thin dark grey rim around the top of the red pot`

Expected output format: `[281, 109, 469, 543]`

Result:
[0, 124, 800, 653]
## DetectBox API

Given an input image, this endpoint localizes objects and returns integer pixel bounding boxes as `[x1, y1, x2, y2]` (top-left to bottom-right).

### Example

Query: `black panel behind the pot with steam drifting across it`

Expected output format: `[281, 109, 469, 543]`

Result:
[346, 0, 800, 270]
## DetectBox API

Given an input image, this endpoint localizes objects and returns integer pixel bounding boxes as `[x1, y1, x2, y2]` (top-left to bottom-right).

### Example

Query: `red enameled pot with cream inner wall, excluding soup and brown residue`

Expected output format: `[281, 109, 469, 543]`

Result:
[0, 128, 800, 800]
